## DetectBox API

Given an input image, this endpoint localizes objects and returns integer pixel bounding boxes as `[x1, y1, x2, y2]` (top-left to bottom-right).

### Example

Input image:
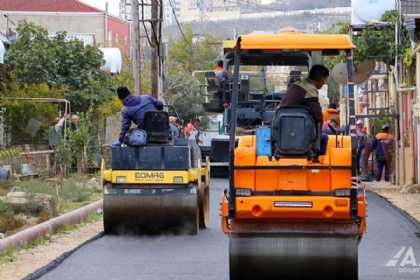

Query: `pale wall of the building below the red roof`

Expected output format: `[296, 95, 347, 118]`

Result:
[0, 12, 106, 46]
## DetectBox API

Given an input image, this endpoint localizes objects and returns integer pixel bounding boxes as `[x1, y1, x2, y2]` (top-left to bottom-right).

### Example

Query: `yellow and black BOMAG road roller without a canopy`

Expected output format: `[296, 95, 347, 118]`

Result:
[102, 109, 210, 234]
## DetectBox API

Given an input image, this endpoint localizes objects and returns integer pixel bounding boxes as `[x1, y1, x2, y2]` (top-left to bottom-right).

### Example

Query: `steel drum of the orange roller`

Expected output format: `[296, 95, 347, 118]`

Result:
[229, 235, 358, 280]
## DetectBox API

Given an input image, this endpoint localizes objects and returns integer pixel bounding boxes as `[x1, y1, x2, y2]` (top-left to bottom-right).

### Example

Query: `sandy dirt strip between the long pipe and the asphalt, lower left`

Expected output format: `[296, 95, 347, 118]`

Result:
[0, 221, 103, 280]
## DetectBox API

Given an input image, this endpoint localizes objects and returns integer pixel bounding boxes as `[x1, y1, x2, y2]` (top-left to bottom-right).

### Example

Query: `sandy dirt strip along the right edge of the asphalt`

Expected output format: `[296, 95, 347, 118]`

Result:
[366, 182, 420, 222]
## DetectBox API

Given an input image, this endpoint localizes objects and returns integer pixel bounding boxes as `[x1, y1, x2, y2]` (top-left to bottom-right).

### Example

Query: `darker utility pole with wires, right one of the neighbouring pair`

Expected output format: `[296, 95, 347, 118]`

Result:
[151, 0, 163, 98]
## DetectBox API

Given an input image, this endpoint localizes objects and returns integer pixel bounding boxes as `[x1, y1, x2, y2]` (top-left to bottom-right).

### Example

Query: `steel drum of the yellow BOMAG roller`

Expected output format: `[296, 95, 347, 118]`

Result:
[104, 185, 199, 234]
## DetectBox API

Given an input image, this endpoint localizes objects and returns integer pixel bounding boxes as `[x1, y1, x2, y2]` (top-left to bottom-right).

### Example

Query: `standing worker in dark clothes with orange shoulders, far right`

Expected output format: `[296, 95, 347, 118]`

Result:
[373, 124, 394, 182]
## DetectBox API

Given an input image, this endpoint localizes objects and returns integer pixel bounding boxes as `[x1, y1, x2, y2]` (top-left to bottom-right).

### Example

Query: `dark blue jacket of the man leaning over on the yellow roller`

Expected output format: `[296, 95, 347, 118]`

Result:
[119, 95, 163, 143]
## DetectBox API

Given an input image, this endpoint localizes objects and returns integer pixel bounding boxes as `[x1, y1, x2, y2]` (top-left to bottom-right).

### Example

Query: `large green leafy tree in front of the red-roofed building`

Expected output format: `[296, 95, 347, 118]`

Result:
[6, 22, 114, 111]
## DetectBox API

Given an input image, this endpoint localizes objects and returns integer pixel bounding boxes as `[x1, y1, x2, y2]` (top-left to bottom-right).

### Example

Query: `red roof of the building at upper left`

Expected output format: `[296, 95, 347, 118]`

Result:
[0, 0, 103, 13]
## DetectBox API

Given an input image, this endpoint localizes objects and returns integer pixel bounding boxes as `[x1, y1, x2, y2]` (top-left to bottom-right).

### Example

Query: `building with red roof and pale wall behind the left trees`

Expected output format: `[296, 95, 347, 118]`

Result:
[0, 0, 130, 56]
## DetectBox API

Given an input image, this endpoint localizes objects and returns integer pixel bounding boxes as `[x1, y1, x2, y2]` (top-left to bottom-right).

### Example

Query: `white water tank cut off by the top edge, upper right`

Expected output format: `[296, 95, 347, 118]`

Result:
[351, 0, 395, 25]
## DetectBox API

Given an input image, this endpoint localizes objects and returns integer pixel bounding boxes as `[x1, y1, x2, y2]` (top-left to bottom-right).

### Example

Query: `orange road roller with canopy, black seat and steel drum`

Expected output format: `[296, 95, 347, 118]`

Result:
[221, 32, 366, 280]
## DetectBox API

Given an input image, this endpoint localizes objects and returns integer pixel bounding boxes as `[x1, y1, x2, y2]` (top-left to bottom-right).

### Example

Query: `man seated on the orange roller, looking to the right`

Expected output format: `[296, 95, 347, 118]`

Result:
[280, 65, 330, 159]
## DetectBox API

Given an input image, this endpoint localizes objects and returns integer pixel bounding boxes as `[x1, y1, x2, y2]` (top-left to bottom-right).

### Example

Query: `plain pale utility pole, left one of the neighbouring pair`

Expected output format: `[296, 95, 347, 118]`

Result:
[131, 0, 141, 95]
